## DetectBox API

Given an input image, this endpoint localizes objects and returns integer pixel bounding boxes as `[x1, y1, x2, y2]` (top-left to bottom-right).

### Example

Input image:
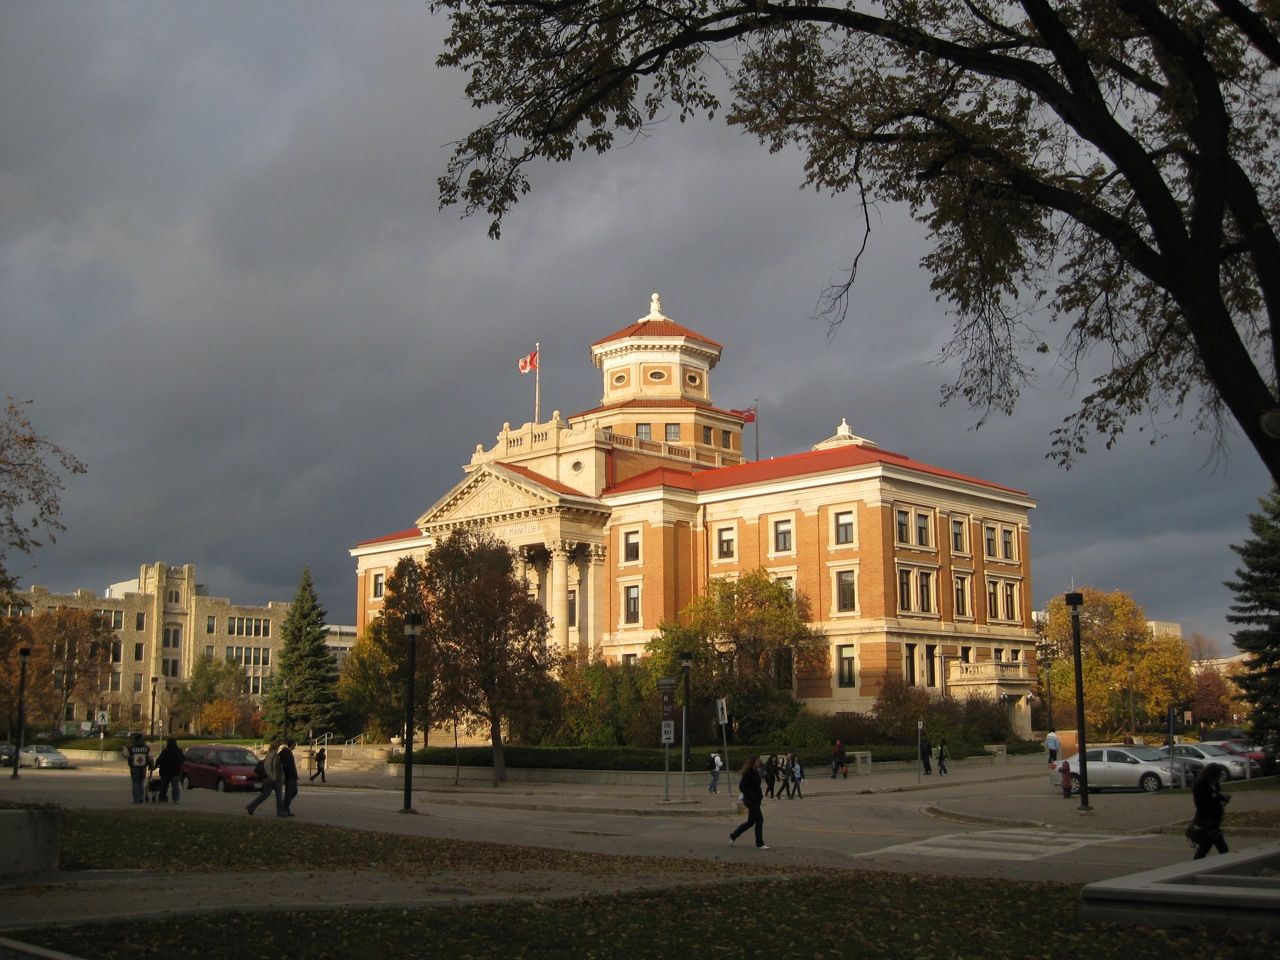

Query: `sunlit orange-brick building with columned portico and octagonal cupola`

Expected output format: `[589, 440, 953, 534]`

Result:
[351, 294, 1036, 735]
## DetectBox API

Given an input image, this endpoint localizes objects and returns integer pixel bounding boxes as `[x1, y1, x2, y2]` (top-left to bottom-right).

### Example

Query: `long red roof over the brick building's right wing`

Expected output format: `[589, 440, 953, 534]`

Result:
[602, 444, 1027, 497]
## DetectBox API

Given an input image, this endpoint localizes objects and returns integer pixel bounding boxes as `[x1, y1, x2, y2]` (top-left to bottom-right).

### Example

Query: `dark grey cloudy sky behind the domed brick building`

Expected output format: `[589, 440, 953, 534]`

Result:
[0, 0, 1268, 655]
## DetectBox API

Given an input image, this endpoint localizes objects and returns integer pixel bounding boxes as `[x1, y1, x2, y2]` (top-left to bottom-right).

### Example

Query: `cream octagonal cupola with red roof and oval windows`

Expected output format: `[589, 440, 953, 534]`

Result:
[591, 293, 723, 404]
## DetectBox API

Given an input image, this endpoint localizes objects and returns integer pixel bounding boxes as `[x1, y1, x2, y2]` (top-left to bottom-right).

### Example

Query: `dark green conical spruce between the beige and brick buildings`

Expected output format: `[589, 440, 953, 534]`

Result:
[266, 568, 342, 740]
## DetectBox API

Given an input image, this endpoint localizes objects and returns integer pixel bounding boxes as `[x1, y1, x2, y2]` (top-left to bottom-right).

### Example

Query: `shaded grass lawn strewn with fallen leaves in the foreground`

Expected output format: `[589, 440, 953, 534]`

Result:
[17, 810, 1280, 960]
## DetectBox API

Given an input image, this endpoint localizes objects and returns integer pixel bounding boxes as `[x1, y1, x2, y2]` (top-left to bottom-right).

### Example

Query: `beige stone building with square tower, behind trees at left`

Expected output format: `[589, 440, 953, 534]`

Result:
[9, 563, 289, 732]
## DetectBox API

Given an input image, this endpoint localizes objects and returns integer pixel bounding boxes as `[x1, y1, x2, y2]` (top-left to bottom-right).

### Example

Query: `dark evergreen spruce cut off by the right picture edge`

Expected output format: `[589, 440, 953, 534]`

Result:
[1226, 489, 1280, 748]
